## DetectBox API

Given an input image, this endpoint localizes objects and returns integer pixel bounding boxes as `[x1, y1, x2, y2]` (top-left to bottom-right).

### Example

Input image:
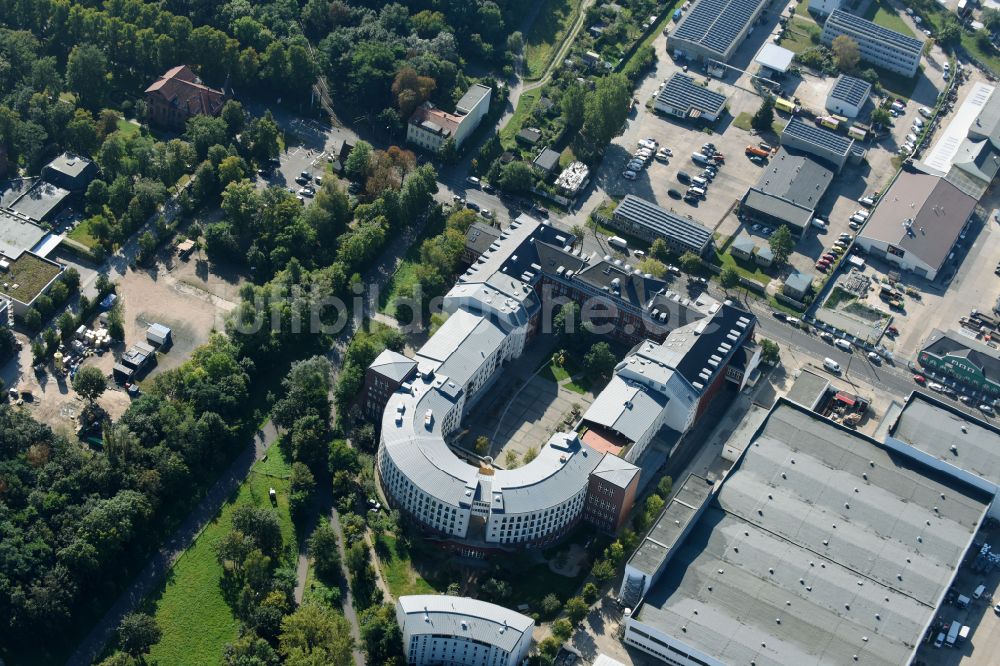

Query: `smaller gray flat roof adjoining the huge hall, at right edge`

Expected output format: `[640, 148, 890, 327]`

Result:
[889, 391, 1000, 485]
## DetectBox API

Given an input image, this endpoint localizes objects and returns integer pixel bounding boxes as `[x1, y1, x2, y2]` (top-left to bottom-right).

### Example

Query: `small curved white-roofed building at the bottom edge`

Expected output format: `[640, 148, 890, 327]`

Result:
[396, 594, 535, 666]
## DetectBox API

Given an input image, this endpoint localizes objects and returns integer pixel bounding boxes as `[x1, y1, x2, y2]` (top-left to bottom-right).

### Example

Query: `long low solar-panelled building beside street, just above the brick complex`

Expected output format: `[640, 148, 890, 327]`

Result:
[611, 194, 712, 256]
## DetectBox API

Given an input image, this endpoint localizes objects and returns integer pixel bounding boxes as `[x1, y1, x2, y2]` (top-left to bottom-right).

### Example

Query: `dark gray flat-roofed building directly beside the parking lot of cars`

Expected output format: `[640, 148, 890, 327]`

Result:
[740, 147, 833, 235]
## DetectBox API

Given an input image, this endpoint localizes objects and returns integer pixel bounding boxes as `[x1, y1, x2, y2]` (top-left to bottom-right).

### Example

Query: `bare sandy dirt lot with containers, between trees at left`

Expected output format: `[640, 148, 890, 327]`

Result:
[0, 243, 240, 434]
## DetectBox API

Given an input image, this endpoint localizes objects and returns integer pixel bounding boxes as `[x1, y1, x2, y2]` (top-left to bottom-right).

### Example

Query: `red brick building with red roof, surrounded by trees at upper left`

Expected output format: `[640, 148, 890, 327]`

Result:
[146, 65, 226, 130]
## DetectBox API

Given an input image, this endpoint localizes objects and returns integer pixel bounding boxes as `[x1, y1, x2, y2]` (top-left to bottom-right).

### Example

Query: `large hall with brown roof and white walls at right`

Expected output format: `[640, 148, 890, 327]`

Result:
[855, 171, 976, 280]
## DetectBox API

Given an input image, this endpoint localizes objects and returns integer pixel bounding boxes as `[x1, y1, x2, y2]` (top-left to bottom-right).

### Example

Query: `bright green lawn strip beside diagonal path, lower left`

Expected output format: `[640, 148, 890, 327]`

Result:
[146, 445, 297, 666]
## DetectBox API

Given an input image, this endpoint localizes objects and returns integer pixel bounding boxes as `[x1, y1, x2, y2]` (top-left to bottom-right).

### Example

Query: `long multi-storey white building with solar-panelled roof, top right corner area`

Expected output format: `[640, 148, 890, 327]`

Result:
[820, 9, 924, 76]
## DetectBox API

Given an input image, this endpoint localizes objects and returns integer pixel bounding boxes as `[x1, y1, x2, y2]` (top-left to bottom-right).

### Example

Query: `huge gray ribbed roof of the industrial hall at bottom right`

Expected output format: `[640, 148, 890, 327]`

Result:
[633, 399, 989, 666]
